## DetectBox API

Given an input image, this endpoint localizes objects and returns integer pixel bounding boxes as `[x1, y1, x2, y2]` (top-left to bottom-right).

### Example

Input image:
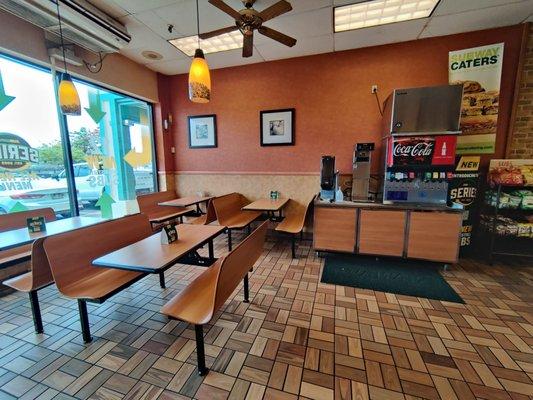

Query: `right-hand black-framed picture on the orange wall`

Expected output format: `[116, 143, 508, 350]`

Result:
[260, 108, 294, 146]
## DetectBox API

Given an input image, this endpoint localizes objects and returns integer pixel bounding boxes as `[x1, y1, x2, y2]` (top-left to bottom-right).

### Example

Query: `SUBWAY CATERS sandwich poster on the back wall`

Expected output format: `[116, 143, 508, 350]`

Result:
[448, 43, 503, 154]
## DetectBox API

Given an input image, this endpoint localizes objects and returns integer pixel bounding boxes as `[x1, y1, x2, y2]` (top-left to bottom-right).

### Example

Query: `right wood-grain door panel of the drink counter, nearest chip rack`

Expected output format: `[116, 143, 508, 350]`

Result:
[407, 211, 462, 263]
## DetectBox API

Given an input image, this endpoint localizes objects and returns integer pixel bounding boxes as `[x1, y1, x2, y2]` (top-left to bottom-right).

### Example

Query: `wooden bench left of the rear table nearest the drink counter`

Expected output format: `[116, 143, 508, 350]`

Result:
[213, 193, 261, 251]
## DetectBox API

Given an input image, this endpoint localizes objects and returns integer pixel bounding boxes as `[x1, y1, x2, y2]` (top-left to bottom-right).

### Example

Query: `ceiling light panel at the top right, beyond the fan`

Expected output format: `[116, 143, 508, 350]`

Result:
[333, 0, 439, 32]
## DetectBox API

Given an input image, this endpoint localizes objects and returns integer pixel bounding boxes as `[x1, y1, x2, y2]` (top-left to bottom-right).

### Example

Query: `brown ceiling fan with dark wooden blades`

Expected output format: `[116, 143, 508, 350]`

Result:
[200, 0, 296, 57]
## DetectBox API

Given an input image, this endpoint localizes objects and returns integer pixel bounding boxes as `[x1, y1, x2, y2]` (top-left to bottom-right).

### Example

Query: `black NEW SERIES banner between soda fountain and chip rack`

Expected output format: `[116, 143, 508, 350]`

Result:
[448, 156, 480, 252]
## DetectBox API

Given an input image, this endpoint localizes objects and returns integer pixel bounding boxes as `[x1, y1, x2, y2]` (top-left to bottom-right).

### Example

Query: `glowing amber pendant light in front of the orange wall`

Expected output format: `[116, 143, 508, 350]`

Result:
[189, 0, 211, 103]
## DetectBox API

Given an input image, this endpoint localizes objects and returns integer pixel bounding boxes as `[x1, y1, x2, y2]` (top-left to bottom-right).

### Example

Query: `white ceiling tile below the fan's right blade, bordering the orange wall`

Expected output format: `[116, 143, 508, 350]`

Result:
[256, 34, 334, 61]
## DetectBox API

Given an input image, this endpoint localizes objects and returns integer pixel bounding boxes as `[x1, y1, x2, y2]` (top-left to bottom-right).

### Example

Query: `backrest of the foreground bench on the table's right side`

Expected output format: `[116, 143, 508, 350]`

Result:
[213, 221, 268, 312]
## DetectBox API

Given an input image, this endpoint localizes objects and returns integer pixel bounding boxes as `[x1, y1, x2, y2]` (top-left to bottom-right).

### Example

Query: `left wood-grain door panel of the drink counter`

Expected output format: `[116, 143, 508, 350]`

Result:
[313, 207, 357, 253]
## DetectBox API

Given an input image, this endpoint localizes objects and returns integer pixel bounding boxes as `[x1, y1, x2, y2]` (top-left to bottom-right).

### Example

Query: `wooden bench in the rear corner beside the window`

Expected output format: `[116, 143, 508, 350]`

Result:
[137, 190, 194, 228]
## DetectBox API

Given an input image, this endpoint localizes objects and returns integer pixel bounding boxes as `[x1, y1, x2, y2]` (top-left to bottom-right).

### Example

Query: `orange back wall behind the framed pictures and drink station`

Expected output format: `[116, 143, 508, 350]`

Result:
[166, 25, 522, 173]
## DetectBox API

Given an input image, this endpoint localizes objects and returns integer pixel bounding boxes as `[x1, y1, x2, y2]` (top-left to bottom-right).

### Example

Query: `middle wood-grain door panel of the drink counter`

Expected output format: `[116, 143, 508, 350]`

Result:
[359, 210, 406, 257]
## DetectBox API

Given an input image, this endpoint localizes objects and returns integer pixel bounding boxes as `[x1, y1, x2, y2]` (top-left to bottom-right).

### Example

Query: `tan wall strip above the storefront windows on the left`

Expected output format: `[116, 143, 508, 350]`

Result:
[0, 11, 158, 103]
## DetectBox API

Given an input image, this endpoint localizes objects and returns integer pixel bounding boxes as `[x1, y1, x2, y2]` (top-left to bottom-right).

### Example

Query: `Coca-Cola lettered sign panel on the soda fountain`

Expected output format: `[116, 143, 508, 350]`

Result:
[392, 136, 435, 166]
